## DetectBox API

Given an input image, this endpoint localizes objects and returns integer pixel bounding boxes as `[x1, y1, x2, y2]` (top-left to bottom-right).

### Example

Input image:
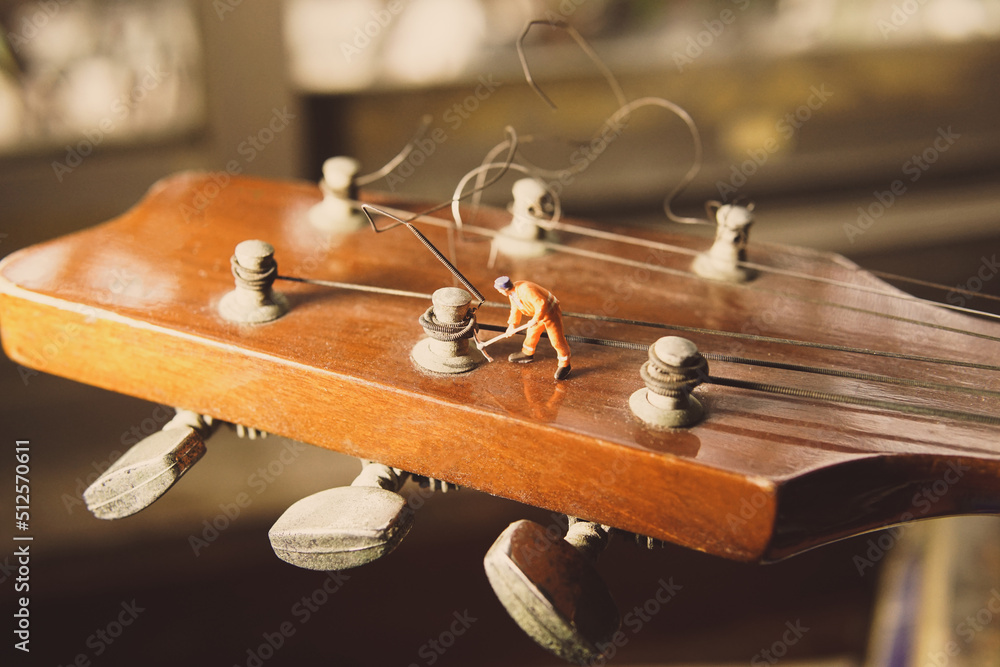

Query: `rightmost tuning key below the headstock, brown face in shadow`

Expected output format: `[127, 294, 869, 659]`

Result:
[483, 521, 621, 664]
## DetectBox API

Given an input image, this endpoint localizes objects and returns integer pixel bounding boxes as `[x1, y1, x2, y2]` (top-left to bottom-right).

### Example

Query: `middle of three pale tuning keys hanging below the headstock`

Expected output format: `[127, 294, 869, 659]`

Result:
[268, 461, 413, 570]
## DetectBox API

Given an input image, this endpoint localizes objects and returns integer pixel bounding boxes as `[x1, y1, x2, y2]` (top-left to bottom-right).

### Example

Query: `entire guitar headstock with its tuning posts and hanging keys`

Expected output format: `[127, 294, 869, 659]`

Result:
[0, 173, 1000, 661]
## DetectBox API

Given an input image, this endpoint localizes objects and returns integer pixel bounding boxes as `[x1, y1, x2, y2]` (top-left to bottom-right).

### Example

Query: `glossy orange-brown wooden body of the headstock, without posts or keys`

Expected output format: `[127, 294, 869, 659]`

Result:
[0, 173, 1000, 561]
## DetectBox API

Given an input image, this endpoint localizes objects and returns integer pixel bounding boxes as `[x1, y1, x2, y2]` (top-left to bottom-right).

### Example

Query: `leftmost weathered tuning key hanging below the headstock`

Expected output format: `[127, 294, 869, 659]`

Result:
[83, 409, 213, 519]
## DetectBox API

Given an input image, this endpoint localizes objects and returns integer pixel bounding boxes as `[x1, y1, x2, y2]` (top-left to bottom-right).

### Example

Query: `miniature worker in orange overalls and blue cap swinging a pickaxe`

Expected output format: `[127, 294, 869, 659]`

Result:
[493, 276, 570, 380]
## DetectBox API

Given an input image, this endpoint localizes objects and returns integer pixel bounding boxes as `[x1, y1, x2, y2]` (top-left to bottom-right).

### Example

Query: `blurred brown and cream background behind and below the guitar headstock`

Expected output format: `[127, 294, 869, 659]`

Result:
[0, 0, 1000, 667]
